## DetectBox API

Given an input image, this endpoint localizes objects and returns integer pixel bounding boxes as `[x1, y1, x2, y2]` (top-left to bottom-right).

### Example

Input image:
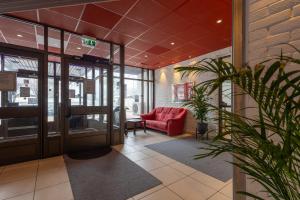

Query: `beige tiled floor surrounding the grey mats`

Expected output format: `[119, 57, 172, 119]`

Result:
[0, 131, 232, 200]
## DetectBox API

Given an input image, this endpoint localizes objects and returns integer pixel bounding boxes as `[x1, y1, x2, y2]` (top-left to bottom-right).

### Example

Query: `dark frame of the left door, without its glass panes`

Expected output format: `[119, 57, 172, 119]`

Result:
[0, 43, 45, 165]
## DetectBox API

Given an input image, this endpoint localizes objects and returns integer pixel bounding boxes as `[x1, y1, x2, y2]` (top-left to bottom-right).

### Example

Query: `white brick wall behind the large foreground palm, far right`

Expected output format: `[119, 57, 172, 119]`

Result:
[245, 0, 300, 199]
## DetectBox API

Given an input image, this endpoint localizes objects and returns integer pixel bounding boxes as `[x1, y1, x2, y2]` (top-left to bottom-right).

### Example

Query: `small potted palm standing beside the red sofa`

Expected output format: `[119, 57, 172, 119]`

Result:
[183, 87, 209, 135]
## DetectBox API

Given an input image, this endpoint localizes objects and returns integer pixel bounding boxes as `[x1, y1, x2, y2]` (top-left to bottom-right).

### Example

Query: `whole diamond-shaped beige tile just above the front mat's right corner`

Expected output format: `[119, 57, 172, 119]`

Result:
[150, 166, 185, 185]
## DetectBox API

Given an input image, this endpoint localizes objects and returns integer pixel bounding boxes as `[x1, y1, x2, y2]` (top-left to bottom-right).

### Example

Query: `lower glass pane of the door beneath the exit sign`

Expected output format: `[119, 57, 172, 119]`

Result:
[69, 114, 108, 134]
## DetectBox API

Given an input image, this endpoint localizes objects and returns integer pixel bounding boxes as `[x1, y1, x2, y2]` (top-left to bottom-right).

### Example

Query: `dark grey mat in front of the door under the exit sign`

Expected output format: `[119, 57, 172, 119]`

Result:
[65, 150, 161, 200]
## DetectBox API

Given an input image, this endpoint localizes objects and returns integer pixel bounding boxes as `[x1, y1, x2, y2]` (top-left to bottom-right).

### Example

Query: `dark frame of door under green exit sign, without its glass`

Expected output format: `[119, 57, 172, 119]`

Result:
[61, 55, 113, 153]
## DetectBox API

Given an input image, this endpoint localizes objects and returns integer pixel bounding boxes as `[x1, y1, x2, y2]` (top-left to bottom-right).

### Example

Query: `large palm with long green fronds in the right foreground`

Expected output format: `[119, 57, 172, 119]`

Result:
[176, 48, 300, 200]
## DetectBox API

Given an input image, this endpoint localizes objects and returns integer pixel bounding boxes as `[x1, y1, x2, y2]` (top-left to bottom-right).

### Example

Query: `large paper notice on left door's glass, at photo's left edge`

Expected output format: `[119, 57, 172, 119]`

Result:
[0, 72, 17, 91]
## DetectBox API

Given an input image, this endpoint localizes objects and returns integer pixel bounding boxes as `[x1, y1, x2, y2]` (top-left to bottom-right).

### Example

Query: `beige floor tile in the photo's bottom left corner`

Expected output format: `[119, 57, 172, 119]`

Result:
[0, 178, 35, 200]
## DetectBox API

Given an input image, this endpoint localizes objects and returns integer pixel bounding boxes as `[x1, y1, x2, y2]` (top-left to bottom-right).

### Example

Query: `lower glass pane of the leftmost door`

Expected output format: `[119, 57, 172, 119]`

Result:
[0, 117, 39, 141]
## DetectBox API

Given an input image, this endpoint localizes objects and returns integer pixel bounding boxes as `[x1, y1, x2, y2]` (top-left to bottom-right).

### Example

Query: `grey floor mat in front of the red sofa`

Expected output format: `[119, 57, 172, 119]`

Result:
[146, 137, 233, 182]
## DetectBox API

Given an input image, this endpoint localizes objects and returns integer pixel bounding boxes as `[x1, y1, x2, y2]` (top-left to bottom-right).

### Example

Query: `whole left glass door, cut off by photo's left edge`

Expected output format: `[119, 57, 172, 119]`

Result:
[0, 47, 44, 165]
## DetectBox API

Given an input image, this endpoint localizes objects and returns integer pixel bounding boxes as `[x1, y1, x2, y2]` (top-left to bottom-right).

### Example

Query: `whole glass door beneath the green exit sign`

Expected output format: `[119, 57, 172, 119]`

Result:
[62, 58, 111, 152]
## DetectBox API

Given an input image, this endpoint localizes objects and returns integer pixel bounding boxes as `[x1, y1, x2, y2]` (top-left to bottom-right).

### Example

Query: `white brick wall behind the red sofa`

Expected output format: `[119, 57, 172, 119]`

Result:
[155, 47, 231, 133]
